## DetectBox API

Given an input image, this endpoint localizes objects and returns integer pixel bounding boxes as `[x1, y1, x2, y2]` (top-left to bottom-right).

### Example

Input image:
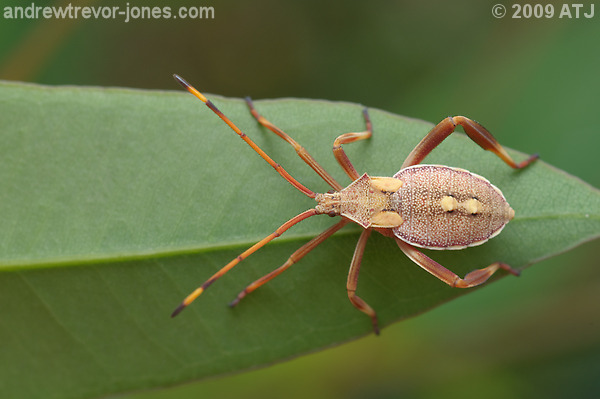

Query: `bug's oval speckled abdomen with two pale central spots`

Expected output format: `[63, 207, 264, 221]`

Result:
[393, 165, 514, 249]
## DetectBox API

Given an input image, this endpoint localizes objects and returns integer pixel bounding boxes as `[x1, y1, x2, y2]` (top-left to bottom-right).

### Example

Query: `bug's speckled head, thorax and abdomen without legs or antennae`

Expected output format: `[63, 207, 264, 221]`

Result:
[316, 165, 514, 249]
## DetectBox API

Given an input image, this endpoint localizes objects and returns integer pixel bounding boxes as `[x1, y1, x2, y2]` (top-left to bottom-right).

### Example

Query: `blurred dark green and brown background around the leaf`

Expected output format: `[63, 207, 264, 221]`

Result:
[0, 0, 600, 398]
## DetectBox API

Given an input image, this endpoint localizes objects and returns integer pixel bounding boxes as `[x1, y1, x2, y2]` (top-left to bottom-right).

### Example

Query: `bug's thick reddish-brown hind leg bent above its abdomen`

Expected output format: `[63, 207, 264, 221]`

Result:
[402, 116, 539, 169]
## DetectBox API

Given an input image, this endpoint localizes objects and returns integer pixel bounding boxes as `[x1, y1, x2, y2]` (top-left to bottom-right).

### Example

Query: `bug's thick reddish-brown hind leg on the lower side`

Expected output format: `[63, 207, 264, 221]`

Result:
[394, 237, 519, 288]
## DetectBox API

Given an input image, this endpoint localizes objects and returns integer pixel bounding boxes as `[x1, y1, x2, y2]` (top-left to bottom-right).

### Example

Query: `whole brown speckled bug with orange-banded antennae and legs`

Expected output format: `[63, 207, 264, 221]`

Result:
[171, 75, 538, 334]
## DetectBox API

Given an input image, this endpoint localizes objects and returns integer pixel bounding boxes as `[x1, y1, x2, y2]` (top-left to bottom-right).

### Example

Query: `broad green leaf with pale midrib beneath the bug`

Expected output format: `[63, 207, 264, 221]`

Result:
[0, 82, 600, 398]
